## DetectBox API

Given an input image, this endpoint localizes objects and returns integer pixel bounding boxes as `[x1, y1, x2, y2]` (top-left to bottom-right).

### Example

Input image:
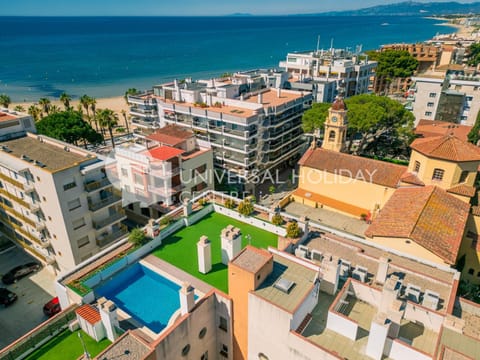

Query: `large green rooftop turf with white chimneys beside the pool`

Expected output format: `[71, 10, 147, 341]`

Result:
[153, 213, 278, 292]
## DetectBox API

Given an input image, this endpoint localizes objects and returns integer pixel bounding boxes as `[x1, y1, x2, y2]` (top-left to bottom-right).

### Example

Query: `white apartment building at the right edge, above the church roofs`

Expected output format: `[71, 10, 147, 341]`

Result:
[407, 74, 480, 125]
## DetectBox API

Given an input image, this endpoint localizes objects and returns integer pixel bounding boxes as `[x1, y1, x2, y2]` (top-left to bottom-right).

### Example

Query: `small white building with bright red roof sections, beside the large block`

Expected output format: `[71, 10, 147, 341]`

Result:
[111, 125, 214, 223]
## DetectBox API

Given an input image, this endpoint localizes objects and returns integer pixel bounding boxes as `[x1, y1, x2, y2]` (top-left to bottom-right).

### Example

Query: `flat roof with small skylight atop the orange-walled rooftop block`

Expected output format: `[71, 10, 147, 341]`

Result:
[253, 254, 318, 313]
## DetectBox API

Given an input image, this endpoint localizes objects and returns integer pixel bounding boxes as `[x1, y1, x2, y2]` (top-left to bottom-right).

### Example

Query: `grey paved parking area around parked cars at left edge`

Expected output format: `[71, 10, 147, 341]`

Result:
[0, 248, 55, 349]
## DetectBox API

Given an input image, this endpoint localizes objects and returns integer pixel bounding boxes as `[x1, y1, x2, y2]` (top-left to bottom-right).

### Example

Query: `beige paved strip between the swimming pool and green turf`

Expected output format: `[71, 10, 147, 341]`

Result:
[140, 255, 214, 295]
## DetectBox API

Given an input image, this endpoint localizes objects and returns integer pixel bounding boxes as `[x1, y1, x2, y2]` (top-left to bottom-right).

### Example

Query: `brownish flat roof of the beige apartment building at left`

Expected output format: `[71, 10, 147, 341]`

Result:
[1, 136, 94, 171]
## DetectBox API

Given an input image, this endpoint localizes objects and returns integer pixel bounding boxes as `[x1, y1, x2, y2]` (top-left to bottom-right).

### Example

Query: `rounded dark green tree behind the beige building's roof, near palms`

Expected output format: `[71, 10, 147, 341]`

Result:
[36, 110, 102, 145]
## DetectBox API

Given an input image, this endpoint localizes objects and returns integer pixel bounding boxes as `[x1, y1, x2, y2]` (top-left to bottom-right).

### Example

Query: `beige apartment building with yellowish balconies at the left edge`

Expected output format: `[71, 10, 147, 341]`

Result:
[0, 115, 126, 271]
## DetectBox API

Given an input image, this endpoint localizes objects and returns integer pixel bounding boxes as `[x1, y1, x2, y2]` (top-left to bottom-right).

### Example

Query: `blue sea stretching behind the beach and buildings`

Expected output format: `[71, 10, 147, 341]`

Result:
[0, 16, 454, 101]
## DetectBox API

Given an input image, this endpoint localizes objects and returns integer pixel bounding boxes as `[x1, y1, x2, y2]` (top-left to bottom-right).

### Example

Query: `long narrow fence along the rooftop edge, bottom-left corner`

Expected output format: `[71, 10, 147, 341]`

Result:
[0, 305, 77, 360]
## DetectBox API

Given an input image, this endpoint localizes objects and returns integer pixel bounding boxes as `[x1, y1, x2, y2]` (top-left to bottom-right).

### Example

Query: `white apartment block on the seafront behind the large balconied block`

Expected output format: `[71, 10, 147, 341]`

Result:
[279, 49, 377, 102]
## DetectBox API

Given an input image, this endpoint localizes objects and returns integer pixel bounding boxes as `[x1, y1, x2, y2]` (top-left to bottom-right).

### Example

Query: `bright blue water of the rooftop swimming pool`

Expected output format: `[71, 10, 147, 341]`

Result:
[95, 263, 180, 333]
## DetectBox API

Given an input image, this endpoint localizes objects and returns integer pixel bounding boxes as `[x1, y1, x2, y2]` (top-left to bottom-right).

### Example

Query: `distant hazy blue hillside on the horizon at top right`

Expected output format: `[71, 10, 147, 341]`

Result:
[316, 1, 480, 16]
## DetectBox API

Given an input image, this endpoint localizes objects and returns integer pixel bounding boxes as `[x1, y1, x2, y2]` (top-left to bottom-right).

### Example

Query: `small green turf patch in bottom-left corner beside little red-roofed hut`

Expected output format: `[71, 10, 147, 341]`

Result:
[25, 329, 111, 360]
